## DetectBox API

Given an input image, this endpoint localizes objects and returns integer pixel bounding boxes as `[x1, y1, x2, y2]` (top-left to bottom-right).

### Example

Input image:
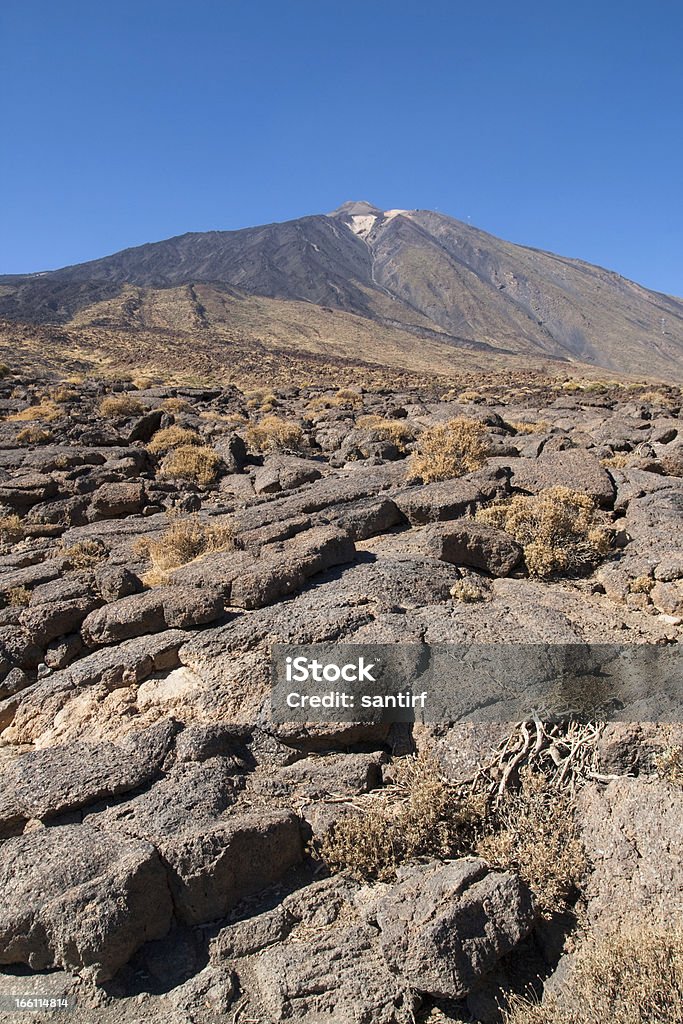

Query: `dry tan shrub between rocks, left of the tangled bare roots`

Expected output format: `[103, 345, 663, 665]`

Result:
[318, 754, 481, 881]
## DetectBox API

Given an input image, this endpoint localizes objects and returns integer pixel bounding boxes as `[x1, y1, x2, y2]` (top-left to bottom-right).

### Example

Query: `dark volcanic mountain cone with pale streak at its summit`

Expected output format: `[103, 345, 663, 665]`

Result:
[0, 203, 683, 379]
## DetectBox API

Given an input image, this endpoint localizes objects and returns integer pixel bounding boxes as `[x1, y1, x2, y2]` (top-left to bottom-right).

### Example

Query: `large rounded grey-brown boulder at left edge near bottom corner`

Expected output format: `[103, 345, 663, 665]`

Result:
[0, 825, 173, 982]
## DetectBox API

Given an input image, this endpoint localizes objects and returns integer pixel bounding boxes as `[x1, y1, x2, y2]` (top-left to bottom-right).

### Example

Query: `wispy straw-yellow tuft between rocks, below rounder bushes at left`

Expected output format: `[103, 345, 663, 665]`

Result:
[134, 513, 237, 587]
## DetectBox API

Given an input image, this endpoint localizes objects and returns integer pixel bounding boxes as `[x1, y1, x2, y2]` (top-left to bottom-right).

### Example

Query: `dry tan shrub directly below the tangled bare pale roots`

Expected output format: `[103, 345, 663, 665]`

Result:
[476, 768, 588, 915]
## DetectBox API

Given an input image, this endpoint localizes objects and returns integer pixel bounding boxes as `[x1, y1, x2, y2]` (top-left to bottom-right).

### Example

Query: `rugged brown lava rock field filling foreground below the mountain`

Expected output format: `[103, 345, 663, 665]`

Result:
[0, 377, 683, 1024]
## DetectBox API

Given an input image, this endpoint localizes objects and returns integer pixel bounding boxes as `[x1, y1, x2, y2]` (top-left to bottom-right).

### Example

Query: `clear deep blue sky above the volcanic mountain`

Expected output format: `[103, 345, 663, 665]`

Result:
[0, 0, 683, 295]
